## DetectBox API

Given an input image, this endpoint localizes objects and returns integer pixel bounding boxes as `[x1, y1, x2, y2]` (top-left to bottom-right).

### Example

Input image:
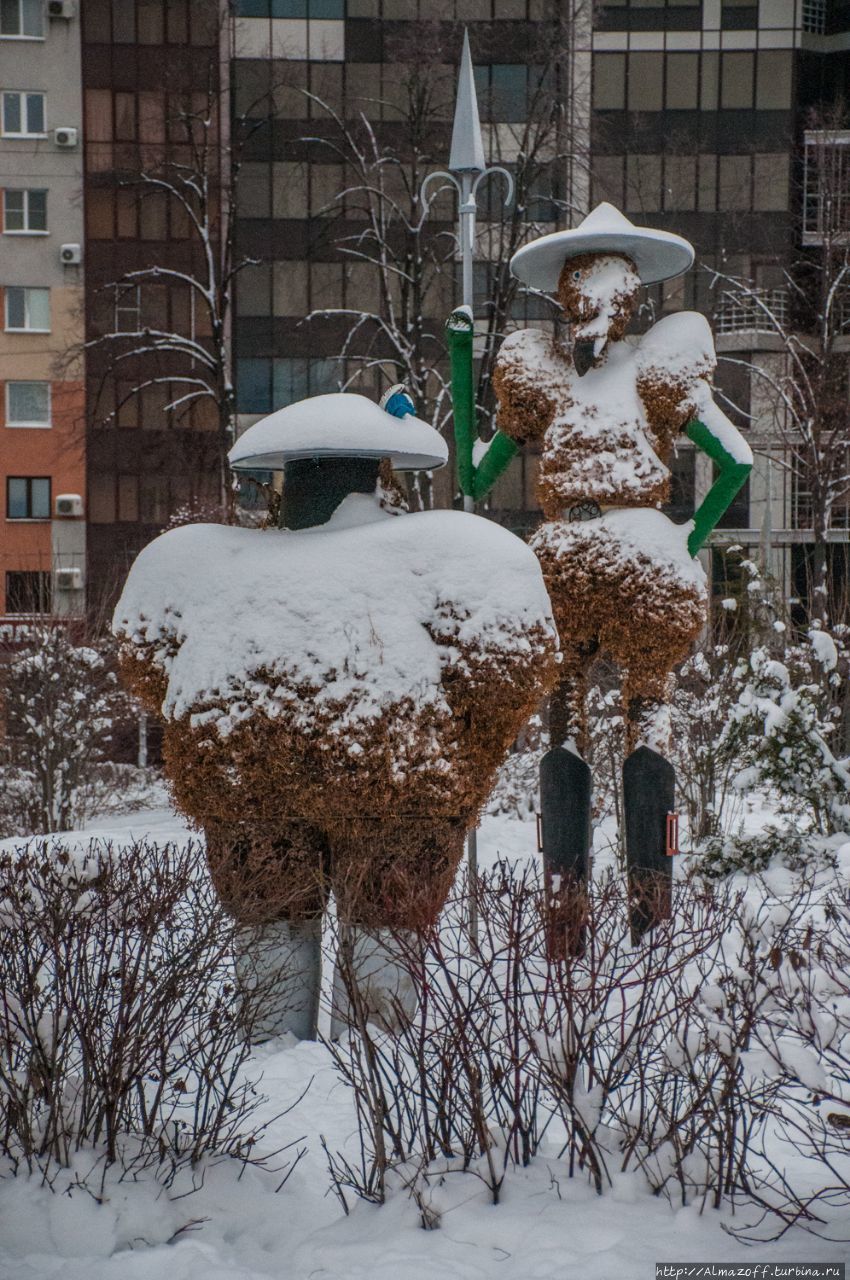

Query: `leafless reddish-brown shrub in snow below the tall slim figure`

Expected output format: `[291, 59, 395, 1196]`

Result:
[322, 864, 850, 1225]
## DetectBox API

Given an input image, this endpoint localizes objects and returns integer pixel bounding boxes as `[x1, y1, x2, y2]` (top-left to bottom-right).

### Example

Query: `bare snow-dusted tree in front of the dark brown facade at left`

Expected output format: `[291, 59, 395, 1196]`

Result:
[86, 11, 280, 509]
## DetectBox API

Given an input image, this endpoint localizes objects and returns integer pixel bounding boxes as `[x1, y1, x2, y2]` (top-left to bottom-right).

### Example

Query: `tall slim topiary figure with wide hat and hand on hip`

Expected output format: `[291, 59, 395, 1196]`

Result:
[494, 205, 753, 947]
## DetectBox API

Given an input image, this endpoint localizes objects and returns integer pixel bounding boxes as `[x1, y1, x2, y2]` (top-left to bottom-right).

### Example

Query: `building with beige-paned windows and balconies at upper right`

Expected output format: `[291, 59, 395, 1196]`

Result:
[591, 0, 850, 614]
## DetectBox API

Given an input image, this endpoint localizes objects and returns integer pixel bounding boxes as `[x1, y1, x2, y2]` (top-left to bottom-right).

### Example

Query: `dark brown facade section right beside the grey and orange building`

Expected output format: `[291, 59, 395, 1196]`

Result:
[82, 0, 227, 612]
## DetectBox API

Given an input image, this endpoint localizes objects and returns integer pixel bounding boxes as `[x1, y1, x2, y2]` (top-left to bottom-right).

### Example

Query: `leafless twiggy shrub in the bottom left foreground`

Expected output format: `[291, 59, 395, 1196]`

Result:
[0, 840, 305, 1187]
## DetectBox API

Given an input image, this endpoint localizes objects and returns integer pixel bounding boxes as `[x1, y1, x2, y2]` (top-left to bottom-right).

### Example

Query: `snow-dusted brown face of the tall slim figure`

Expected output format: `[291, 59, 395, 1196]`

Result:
[558, 253, 640, 375]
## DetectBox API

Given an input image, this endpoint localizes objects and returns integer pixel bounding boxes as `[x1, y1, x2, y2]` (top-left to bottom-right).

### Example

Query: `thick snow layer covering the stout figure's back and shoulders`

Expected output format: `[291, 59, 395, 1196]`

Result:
[113, 511, 558, 735]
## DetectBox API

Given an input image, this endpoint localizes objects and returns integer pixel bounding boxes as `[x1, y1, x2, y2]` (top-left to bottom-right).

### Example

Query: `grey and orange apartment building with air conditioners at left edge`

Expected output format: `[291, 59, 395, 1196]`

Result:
[0, 0, 86, 620]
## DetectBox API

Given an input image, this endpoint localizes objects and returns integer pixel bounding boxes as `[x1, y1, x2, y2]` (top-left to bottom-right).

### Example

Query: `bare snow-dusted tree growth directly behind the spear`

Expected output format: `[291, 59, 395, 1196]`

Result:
[303, 12, 591, 506]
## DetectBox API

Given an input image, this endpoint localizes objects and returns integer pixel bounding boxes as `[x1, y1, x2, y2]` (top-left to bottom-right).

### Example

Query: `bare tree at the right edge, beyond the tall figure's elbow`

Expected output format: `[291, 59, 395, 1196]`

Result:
[714, 108, 850, 621]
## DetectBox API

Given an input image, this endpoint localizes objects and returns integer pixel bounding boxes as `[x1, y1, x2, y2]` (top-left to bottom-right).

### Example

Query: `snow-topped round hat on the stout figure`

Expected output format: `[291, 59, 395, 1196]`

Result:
[228, 392, 448, 471]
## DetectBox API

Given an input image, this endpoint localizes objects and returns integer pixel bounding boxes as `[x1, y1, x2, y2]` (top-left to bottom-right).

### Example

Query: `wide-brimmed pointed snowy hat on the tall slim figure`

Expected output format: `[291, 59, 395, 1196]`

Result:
[511, 204, 694, 292]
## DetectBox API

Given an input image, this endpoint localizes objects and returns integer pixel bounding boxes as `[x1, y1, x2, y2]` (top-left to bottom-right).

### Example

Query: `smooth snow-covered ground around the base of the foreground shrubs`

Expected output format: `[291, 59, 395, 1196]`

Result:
[0, 808, 850, 1280]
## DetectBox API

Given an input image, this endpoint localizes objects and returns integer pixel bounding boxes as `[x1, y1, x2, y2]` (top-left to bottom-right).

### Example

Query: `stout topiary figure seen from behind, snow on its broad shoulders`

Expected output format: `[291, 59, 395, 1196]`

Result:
[114, 393, 557, 1034]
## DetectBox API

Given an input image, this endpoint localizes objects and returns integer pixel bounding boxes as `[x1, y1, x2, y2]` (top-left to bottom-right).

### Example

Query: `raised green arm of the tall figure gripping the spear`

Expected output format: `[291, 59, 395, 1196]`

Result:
[445, 307, 517, 502]
